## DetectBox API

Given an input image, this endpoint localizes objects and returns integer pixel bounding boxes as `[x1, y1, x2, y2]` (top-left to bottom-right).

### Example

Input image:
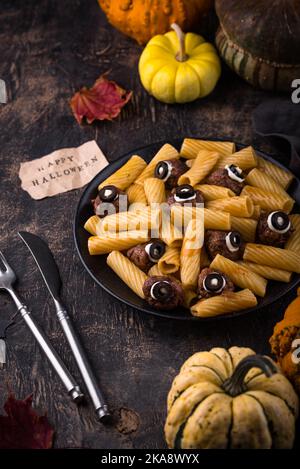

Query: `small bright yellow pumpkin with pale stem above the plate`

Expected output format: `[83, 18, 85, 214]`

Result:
[139, 24, 221, 103]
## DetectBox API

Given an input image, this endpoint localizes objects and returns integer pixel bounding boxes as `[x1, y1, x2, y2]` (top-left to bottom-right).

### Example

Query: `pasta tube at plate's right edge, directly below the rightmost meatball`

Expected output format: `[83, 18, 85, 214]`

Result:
[244, 243, 300, 274]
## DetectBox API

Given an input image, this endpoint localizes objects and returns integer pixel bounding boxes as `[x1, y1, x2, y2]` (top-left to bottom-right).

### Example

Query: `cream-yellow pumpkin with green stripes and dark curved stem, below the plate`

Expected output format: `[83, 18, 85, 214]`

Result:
[165, 347, 298, 449]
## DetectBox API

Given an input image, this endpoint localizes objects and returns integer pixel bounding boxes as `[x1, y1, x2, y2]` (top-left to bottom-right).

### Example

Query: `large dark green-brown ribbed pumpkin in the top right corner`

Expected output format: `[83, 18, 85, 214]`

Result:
[216, 0, 300, 91]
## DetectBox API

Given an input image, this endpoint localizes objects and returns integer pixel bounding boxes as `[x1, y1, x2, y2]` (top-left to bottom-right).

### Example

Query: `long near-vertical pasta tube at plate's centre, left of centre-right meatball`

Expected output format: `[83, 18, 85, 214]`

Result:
[180, 219, 204, 288]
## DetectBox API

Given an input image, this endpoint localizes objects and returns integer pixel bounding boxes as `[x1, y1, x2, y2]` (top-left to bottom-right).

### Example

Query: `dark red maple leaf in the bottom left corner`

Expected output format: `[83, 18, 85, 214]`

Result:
[0, 394, 54, 449]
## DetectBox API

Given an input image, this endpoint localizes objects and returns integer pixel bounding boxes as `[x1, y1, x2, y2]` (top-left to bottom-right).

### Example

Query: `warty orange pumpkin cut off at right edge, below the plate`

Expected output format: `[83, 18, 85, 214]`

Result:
[270, 288, 300, 395]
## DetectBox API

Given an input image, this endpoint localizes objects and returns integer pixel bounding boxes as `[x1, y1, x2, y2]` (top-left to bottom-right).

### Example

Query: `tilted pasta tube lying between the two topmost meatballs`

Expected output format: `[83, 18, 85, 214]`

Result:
[178, 150, 220, 186]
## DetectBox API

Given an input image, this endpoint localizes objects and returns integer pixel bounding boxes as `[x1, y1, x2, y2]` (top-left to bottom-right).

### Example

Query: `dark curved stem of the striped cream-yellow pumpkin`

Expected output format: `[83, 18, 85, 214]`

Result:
[223, 355, 277, 397]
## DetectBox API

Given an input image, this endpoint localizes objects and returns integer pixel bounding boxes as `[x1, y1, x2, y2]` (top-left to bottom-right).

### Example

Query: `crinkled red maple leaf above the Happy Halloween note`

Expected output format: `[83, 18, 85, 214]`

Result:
[70, 74, 132, 124]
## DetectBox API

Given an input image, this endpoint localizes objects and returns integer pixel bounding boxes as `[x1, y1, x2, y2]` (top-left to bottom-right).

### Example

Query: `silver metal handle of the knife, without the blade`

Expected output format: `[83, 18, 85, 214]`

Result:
[56, 302, 110, 421]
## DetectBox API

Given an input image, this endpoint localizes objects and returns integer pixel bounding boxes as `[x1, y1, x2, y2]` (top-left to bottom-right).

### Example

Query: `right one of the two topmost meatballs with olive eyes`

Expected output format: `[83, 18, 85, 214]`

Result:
[206, 165, 245, 195]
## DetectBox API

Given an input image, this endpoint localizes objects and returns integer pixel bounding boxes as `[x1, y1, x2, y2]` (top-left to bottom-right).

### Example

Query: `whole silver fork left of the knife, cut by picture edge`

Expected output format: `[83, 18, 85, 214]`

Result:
[0, 251, 83, 403]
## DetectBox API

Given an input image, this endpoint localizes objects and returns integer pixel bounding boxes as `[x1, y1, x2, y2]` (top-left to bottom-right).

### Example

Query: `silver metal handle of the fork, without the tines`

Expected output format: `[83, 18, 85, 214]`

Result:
[9, 290, 84, 403]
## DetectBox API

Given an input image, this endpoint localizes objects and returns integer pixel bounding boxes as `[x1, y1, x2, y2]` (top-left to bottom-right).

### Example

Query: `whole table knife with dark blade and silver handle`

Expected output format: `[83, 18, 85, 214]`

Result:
[19, 231, 110, 422]
